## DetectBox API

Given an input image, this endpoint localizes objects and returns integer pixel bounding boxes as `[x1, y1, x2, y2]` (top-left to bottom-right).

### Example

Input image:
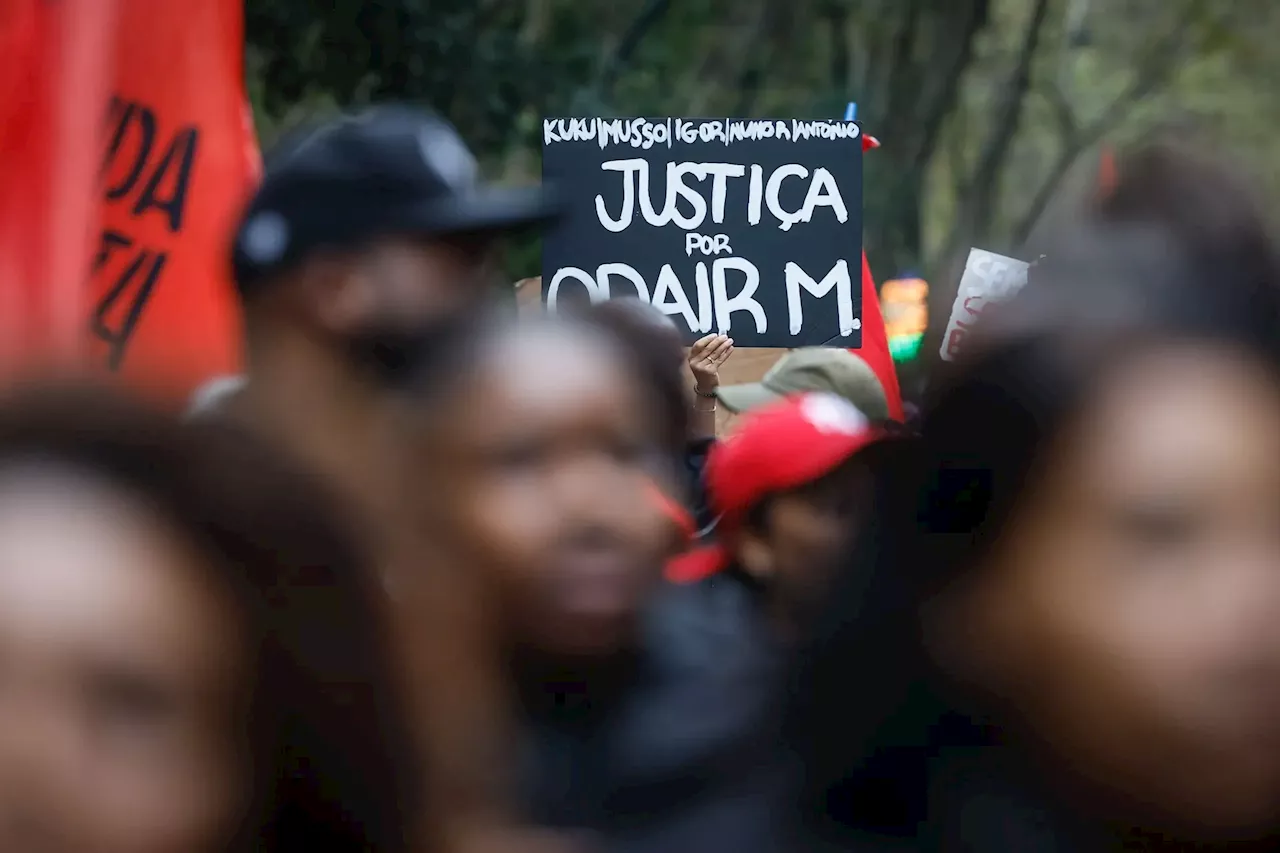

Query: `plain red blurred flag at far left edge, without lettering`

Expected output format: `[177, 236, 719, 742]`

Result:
[0, 0, 116, 374]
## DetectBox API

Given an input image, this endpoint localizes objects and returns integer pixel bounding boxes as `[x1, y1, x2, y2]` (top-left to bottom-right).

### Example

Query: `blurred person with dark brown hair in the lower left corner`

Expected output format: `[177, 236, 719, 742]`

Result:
[0, 389, 417, 853]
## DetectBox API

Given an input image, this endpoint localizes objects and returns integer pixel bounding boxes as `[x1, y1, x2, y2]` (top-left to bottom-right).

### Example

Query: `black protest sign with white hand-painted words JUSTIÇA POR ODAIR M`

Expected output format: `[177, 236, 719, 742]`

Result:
[543, 118, 863, 348]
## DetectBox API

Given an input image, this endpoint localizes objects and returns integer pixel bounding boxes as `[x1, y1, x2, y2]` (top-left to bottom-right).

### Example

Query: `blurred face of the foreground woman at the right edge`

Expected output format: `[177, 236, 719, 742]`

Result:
[957, 347, 1280, 835]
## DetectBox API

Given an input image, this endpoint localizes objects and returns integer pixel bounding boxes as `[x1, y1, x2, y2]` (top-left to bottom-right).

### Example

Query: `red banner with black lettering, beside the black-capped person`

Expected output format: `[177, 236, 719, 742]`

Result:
[90, 0, 261, 400]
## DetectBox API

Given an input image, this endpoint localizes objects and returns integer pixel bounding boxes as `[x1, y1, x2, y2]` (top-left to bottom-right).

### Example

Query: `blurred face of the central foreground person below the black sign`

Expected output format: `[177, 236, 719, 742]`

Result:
[419, 328, 669, 658]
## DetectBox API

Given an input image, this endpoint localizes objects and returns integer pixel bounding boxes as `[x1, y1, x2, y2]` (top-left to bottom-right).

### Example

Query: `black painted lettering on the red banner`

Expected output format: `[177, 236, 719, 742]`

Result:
[90, 97, 200, 370]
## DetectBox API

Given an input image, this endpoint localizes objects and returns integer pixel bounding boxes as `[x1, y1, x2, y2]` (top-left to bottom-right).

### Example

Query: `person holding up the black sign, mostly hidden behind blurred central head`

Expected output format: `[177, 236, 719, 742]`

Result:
[580, 297, 733, 543]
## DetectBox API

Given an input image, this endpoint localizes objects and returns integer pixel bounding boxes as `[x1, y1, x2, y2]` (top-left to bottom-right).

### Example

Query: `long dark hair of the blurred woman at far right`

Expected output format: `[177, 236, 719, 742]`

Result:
[788, 142, 1280, 847]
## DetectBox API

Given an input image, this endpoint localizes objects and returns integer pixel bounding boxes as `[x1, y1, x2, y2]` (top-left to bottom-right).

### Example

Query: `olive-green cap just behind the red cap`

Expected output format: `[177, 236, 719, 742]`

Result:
[716, 347, 890, 424]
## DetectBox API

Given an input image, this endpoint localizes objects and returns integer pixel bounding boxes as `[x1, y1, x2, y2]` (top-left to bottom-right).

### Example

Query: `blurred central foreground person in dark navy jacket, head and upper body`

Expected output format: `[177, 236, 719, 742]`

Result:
[402, 315, 780, 853]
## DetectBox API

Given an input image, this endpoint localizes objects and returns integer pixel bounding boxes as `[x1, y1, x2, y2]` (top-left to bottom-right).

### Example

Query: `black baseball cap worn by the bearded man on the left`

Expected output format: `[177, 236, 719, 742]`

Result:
[232, 106, 558, 293]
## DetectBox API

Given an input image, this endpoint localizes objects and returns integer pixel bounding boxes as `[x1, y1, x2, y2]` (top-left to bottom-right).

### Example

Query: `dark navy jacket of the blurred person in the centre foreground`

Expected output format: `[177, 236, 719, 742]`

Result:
[514, 578, 786, 853]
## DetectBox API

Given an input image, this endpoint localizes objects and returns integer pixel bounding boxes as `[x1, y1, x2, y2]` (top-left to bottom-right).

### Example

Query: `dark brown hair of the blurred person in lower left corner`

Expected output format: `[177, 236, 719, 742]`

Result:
[0, 388, 421, 853]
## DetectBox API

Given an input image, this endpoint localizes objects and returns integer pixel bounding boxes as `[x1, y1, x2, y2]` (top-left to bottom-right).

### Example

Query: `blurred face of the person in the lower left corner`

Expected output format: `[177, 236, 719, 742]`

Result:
[0, 471, 247, 853]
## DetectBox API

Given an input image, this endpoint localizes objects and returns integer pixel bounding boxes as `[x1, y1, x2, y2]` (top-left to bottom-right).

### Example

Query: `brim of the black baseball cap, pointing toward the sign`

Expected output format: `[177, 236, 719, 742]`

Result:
[407, 187, 562, 237]
